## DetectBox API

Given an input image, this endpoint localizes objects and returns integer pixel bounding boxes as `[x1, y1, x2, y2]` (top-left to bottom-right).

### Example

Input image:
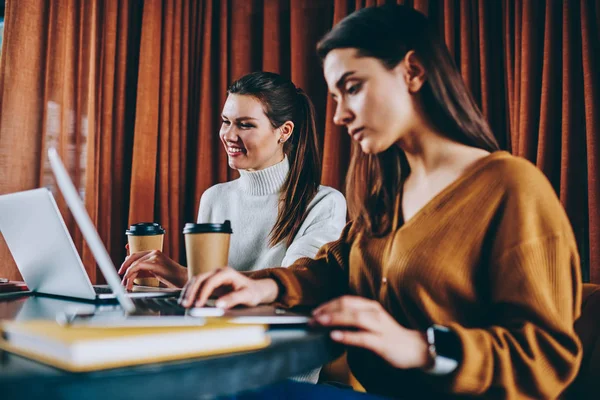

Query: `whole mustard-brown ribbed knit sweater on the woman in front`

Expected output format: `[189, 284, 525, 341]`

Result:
[253, 152, 581, 399]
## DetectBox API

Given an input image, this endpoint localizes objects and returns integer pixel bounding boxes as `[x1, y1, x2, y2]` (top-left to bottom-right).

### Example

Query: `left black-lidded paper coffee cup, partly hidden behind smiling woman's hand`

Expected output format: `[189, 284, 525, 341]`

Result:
[125, 222, 165, 287]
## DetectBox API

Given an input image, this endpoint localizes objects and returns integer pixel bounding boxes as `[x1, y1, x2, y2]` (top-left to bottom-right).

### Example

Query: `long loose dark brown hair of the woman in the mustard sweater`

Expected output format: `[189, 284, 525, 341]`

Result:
[317, 5, 499, 236]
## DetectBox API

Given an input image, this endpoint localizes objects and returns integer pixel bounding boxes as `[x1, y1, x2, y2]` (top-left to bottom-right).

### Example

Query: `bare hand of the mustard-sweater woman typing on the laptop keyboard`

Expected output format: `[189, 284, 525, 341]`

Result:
[180, 267, 279, 308]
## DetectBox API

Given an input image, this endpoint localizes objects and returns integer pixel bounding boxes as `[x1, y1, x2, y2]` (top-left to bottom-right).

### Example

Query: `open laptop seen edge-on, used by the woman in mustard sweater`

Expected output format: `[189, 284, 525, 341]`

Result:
[48, 148, 309, 324]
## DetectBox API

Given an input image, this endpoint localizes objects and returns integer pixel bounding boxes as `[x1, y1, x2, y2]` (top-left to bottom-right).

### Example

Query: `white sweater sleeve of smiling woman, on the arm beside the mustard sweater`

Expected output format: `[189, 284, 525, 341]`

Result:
[281, 190, 346, 267]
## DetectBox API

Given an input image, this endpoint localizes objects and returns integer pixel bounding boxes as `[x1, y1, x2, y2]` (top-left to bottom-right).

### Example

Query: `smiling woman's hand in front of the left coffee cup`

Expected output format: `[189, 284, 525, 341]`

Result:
[119, 250, 187, 290]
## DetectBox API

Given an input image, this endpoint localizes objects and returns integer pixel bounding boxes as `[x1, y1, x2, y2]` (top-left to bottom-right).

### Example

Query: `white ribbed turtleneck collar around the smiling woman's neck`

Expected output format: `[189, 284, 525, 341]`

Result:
[239, 156, 290, 196]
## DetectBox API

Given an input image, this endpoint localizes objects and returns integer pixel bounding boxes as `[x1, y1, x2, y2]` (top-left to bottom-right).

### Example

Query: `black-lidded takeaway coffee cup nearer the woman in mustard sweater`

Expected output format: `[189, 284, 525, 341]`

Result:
[183, 220, 233, 279]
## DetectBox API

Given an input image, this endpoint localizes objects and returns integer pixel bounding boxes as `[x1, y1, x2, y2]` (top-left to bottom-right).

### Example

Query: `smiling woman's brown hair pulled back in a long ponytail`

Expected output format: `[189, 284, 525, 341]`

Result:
[228, 72, 321, 246]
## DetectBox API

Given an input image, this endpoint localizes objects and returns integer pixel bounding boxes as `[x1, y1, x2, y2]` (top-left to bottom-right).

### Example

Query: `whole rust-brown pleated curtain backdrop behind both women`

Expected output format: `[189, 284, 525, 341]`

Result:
[0, 0, 600, 283]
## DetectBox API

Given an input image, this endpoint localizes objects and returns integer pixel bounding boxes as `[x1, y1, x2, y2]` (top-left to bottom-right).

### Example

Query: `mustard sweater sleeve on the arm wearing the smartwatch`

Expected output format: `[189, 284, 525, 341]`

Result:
[442, 164, 582, 399]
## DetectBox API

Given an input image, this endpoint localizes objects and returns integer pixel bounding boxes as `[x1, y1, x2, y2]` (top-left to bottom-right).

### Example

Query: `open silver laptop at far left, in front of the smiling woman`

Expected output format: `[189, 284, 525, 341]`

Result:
[0, 188, 178, 300]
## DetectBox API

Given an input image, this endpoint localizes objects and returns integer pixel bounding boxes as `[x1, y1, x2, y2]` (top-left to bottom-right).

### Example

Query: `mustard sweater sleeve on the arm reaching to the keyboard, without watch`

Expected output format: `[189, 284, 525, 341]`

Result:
[251, 223, 352, 307]
